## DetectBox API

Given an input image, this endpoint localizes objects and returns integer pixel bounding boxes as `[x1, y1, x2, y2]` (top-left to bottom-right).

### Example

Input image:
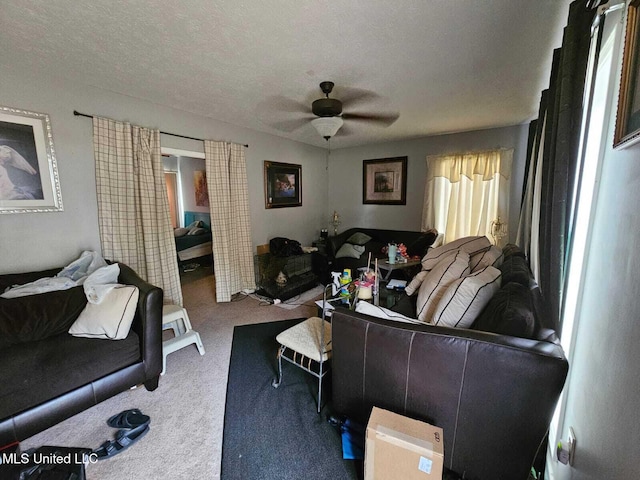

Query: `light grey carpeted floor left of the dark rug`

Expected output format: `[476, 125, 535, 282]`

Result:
[21, 268, 316, 480]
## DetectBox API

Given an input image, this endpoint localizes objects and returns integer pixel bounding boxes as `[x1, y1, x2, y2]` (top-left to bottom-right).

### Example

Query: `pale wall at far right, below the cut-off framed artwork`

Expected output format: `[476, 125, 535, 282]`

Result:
[550, 2, 640, 480]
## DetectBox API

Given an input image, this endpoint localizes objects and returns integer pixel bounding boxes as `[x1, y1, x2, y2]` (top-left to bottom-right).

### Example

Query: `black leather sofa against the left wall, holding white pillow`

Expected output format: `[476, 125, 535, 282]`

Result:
[0, 264, 163, 446]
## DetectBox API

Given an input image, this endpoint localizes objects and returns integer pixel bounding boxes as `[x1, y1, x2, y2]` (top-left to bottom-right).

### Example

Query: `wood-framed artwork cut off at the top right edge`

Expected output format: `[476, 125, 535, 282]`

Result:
[613, 0, 640, 148]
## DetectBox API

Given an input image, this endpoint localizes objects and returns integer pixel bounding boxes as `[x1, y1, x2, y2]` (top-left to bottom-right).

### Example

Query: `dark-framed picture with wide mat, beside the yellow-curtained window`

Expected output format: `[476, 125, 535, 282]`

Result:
[362, 157, 407, 205]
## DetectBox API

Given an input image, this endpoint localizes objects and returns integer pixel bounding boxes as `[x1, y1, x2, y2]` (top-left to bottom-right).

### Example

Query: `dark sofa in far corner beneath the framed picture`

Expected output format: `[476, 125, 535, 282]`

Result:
[326, 227, 438, 275]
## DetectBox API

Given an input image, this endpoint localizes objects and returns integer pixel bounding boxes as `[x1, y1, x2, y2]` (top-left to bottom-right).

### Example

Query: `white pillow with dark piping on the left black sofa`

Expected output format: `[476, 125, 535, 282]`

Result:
[69, 285, 139, 340]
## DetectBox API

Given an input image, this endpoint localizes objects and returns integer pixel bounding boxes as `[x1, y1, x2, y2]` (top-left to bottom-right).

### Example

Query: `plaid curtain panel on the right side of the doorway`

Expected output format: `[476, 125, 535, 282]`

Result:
[204, 140, 256, 302]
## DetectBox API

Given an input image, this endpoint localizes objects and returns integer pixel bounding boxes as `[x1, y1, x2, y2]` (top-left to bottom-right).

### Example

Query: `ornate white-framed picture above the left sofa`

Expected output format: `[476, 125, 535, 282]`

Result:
[0, 107, 63, 214]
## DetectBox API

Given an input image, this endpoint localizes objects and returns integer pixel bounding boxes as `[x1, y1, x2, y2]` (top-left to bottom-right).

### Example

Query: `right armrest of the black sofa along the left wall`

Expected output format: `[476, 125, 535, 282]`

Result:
[118, 263, 163, 378]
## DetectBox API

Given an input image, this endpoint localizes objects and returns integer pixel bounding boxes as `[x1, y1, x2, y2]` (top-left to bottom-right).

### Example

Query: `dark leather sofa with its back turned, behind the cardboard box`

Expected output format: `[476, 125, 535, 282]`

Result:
[332, 246, 568, 480]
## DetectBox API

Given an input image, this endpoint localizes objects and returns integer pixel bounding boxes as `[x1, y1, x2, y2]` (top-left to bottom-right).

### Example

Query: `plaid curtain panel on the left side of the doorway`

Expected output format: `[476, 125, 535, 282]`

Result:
[93, 117, 182, 306]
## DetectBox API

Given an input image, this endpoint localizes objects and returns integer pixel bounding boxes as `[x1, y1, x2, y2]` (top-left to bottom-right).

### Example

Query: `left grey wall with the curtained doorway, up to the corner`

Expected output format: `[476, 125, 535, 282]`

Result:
[0, 67, 327, 273]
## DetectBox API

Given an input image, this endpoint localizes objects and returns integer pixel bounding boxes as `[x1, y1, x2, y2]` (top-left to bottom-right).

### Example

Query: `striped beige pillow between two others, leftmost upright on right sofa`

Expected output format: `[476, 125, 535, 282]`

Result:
[416, 250, 469, 323]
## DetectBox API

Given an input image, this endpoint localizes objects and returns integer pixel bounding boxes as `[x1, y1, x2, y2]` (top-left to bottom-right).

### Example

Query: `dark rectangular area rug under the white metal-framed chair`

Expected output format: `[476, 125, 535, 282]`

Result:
[221, 319, 360, 480]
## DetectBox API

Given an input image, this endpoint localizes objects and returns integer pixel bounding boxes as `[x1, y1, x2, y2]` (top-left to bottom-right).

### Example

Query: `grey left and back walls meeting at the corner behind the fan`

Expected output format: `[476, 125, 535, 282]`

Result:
[0, 63, 527, 273]
